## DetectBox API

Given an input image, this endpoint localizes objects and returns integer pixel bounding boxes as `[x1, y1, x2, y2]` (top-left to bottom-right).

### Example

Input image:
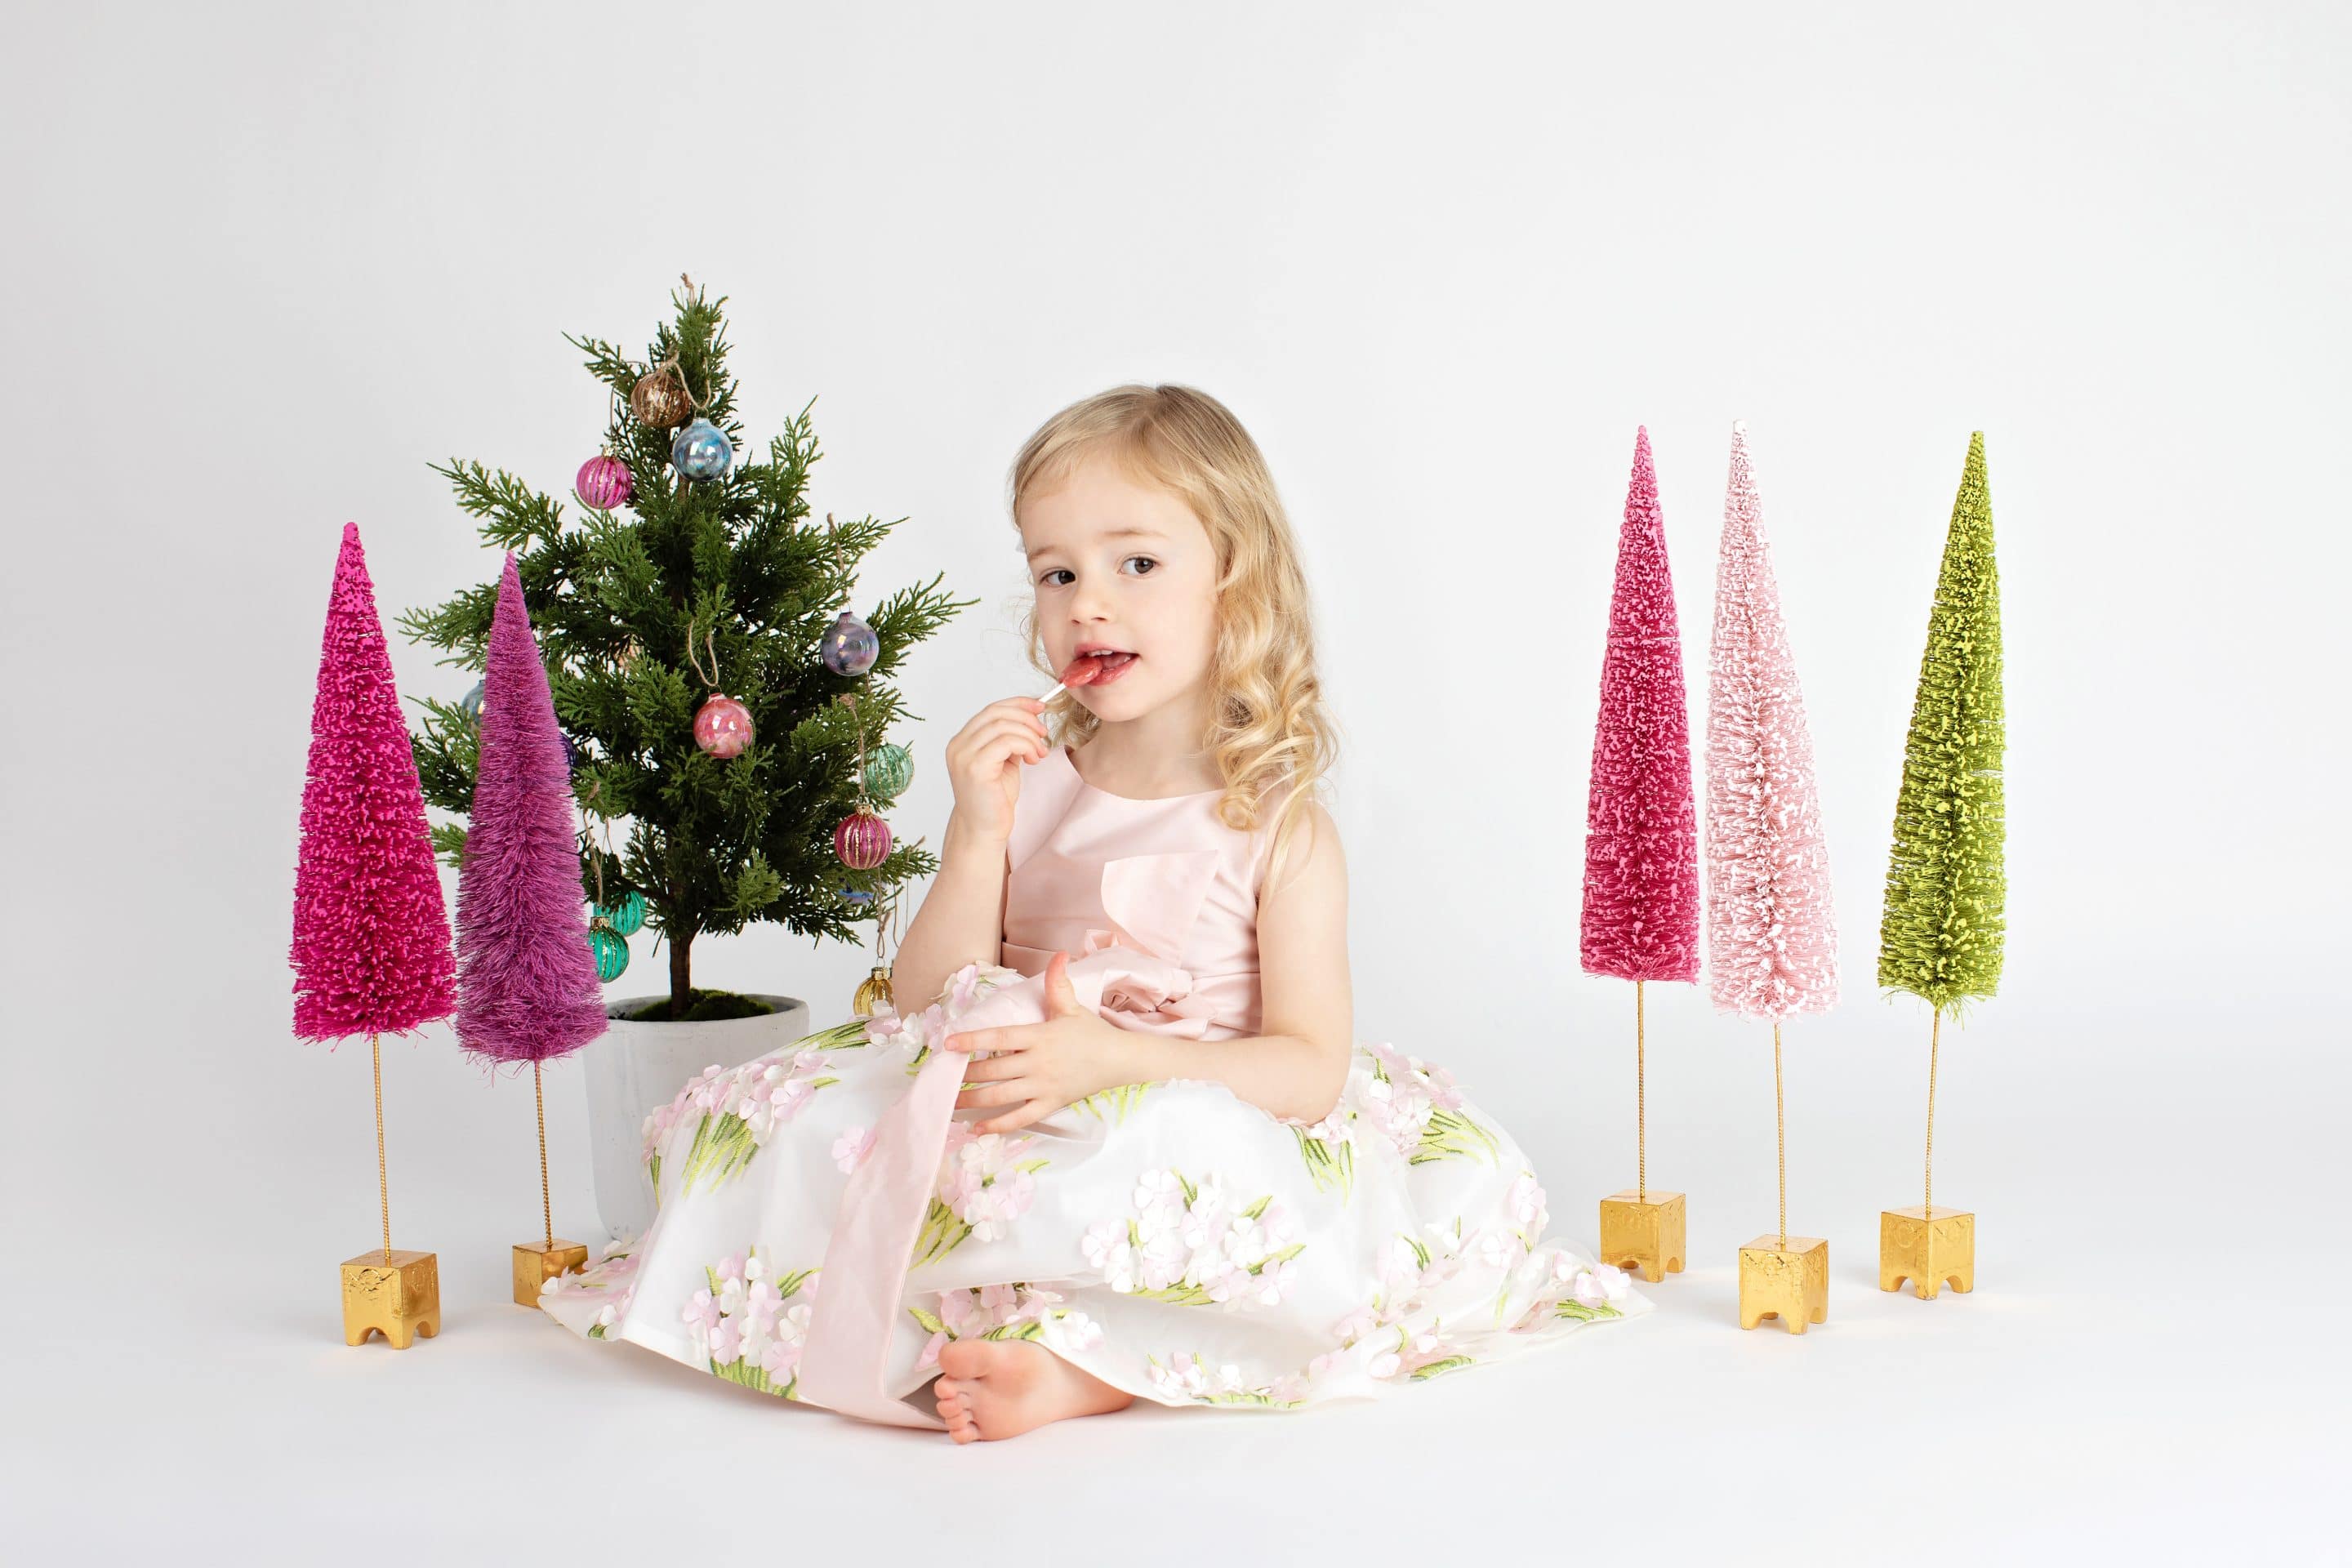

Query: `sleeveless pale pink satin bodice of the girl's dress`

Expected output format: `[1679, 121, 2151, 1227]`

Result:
[1002, 747, 1272, 1039]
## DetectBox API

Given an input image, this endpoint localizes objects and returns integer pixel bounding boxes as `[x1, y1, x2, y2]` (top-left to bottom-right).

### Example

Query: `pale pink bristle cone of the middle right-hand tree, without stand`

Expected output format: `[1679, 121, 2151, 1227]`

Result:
[1708, 423, 1837, 1020]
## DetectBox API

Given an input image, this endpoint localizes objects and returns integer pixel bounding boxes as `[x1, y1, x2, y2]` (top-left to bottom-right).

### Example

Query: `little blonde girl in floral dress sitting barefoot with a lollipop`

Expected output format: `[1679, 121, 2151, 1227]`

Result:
[541, 385, 1649, 1443]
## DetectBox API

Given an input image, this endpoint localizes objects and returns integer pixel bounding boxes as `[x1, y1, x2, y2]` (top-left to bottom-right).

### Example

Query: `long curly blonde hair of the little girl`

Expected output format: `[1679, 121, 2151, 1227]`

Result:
[1009, 385, 1339, 889]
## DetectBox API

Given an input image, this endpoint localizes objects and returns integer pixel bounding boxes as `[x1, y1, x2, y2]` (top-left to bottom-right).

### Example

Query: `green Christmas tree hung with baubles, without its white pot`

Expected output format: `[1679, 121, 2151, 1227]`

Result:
[400, 282, 978, 1018]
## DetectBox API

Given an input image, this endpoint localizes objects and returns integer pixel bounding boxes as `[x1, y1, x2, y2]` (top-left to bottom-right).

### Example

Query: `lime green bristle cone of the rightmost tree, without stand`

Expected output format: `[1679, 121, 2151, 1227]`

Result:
[1879, 430, 2007, 1016]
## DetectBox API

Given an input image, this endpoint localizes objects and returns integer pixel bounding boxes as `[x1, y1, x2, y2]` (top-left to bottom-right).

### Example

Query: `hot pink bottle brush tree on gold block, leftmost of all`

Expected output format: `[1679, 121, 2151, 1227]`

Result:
[292, 522, 454, 1349]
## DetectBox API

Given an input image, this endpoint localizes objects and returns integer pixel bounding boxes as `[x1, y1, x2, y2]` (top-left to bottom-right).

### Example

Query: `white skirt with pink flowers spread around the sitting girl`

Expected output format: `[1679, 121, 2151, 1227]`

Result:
[541, 966, 1651, 1424]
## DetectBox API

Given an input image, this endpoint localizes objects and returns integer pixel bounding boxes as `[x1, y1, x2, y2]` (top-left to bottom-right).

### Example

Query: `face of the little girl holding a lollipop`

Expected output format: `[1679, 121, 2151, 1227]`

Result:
[1016, 456, 1216, 722]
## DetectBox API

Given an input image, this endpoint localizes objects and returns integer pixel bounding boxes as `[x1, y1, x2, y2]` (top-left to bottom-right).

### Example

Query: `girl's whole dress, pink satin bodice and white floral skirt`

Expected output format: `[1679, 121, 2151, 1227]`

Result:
[539, 750, 1651, 1427]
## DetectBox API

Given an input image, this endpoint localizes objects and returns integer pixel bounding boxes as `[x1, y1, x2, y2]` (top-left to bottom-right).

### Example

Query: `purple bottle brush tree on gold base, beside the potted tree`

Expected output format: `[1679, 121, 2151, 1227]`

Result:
[457, 555, 607, 1307]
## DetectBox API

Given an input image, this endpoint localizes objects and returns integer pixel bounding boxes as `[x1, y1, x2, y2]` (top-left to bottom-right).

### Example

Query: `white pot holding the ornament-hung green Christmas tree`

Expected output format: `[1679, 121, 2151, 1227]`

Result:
[581, 997, 809, 1239]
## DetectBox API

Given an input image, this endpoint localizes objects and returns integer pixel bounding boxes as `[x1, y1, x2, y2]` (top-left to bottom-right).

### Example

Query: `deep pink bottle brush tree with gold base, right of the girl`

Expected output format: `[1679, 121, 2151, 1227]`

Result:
[1583, 428, 1698, 1281]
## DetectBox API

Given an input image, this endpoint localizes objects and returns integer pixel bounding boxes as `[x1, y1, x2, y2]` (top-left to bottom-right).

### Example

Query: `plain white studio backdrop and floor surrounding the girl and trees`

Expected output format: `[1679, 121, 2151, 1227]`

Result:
[0, 2, 2352, 1561]
